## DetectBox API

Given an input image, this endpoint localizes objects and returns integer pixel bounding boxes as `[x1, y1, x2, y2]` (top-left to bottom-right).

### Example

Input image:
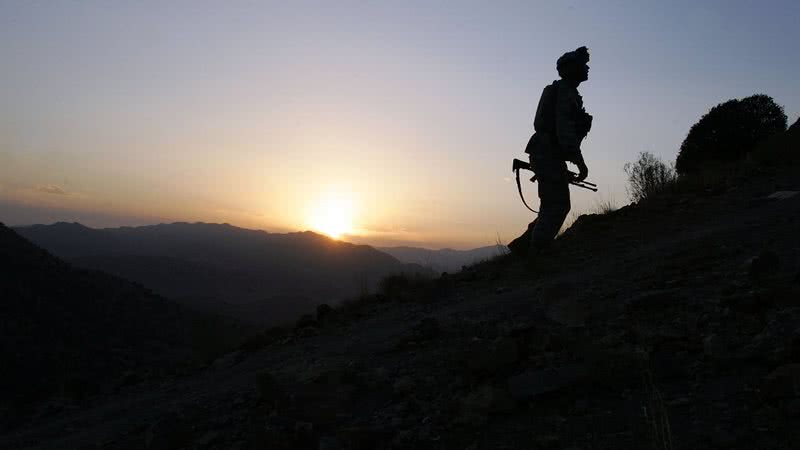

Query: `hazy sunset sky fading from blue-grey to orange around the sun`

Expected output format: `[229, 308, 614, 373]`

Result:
[0, 0, 800, 248]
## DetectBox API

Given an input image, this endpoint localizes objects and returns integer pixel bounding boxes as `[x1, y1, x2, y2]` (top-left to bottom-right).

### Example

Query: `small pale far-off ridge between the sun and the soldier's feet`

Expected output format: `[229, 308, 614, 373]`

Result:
[378, 245, 505, 272]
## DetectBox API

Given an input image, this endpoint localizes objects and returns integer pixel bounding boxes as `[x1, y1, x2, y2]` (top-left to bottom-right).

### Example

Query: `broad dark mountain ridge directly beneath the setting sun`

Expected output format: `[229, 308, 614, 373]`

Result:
[15, 222, 426, 323]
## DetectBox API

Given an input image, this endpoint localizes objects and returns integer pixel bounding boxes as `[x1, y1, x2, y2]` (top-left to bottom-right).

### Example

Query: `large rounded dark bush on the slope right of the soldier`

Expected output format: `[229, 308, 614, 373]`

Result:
[675, 94, 787, 175]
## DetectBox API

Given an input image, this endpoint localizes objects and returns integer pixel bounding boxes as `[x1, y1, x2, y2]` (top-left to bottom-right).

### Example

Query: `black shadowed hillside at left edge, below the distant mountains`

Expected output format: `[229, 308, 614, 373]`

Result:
[0, 224, 244, 424]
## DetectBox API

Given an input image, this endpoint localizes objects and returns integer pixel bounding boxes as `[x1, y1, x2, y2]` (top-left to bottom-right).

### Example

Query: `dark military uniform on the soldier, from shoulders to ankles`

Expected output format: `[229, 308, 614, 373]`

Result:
[525, 80, 591, 249]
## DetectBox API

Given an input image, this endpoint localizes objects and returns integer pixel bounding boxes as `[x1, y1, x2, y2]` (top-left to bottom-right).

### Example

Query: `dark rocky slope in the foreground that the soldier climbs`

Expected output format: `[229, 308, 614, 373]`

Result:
[0, 157, 800, 450]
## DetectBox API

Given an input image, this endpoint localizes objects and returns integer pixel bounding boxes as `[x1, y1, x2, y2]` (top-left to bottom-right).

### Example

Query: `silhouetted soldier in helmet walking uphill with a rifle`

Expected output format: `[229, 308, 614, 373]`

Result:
[508, 47, 592, 254]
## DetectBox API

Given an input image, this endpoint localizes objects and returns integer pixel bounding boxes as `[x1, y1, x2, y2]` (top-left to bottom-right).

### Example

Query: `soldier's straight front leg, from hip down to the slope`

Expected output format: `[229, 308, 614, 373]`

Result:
[531, 176, 570, 250]
